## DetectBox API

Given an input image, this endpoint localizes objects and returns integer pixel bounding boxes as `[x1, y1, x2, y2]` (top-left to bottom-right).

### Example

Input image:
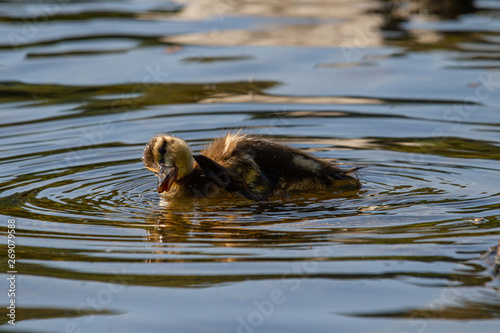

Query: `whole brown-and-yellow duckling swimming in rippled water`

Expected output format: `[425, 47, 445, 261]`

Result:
[142, 133, 360, 201]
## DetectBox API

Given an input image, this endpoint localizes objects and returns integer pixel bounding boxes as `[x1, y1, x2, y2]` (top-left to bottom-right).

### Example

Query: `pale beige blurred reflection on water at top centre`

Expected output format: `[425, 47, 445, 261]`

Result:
[160, 0, 382, 48]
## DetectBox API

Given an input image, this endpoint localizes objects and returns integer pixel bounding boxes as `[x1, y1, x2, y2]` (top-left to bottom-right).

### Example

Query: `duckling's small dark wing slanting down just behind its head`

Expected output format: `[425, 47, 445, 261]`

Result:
[193, 155, 268, 201]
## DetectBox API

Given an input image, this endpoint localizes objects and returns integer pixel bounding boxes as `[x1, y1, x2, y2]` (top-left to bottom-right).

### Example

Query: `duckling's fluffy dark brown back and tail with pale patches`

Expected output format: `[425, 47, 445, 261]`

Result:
[204, 134, 358, 194]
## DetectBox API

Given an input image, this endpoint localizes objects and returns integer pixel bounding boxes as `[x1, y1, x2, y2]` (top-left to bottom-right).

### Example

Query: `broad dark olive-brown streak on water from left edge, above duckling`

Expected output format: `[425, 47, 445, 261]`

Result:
[0, 81, 279, 115]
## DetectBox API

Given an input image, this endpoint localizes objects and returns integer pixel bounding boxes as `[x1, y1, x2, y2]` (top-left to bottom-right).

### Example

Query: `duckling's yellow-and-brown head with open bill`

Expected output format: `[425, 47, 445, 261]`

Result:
[142, 134, 193, 193]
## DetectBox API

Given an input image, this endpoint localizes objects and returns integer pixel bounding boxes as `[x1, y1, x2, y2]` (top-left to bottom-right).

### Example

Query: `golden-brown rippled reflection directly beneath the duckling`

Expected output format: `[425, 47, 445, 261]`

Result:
[147, 185, 363, 252]
